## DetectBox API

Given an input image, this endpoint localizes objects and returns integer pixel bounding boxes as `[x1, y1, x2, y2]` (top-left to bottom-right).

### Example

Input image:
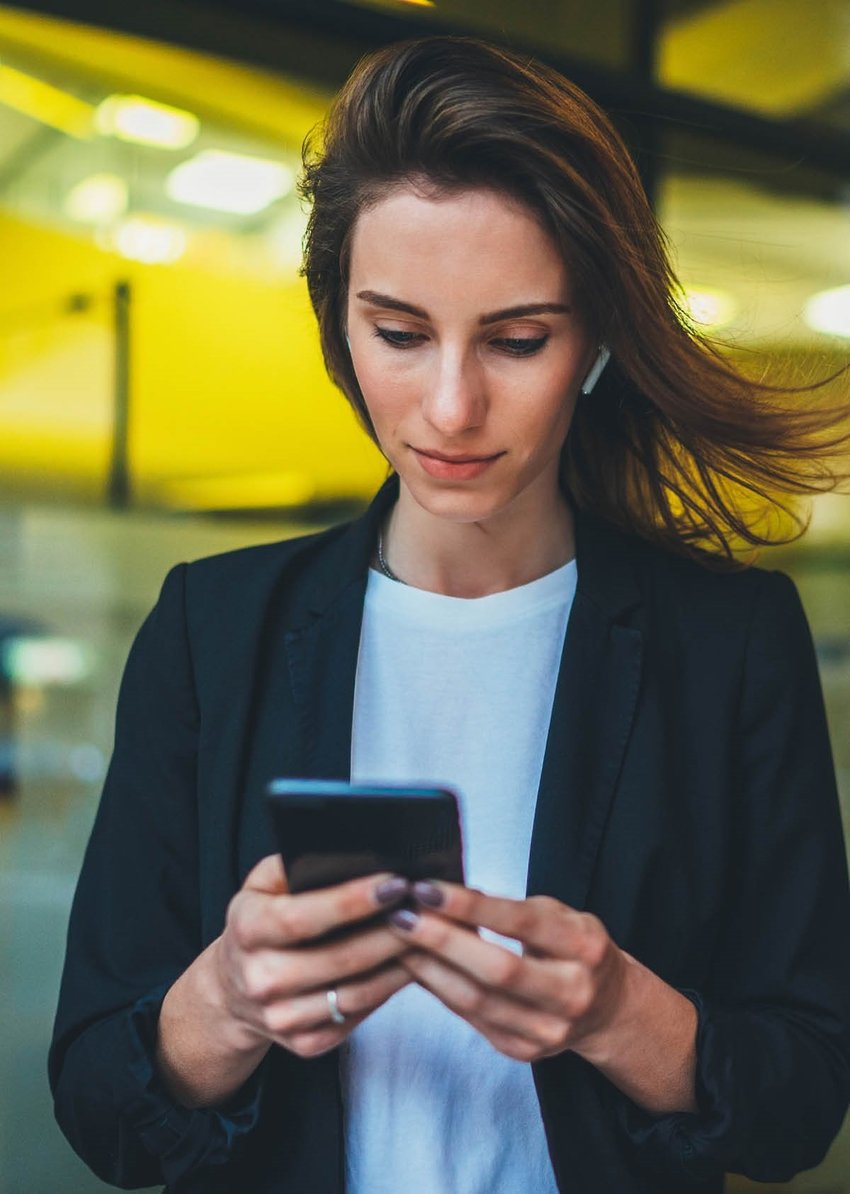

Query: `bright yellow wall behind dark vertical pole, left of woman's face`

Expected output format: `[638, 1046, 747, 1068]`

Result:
[0, 216, 386, 507]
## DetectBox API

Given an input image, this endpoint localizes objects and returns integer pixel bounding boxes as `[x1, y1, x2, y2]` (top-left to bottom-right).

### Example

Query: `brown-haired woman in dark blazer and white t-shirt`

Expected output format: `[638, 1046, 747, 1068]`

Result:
[50, 38, 850, 1194]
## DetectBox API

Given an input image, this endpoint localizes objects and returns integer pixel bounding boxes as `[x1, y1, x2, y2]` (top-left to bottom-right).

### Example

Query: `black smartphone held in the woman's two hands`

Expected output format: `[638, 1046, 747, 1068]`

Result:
[266, 778, 463, 892]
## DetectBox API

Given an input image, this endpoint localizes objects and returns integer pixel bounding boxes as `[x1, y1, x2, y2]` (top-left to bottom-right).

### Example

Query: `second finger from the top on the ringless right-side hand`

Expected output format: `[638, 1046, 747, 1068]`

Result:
[389, 911, 575, 1013]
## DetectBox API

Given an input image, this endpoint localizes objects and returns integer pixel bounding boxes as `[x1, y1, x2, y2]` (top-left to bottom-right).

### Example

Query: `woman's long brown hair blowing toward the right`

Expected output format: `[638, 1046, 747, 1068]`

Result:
[300, 37, 850, 568]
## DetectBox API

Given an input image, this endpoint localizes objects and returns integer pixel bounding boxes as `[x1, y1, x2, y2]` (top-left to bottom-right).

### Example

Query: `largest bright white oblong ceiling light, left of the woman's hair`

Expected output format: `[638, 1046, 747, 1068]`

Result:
[166, 149, 295, 216]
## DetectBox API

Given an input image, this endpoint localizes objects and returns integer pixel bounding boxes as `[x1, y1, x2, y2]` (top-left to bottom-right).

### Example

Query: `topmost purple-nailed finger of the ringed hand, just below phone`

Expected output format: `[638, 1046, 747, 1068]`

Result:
[228, 874, 409, 949]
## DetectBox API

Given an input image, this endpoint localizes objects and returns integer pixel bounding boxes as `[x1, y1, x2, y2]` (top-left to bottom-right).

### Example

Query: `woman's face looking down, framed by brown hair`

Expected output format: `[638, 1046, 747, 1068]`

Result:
[347, 185, 595, 522]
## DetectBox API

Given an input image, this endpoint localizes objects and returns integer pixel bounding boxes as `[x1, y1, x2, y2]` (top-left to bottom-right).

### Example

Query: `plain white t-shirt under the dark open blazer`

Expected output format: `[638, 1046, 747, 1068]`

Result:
[343, 561, 577, 1194]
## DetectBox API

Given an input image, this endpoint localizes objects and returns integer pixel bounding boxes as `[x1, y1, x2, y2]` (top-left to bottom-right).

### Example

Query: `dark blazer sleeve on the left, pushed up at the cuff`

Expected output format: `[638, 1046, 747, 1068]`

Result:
[48, 565, 259, 1189]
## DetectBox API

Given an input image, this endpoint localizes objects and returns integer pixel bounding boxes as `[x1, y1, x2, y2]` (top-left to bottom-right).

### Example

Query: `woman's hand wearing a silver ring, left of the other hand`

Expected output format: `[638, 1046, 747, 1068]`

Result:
[215, 855, 411, 1057]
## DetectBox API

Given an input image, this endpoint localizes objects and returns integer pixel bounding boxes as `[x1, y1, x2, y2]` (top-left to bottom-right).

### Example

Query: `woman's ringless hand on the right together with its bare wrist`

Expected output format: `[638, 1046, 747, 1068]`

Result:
[388, 882, 698, 1115]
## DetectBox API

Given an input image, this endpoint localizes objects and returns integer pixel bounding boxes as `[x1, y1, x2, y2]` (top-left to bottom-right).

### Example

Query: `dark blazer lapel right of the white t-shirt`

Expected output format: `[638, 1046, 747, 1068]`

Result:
[528, 511, 642, 909]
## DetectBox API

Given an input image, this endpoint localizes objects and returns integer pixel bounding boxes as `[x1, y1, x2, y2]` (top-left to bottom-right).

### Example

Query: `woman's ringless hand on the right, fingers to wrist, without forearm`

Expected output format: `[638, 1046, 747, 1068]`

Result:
[389, 882, 634, 1061]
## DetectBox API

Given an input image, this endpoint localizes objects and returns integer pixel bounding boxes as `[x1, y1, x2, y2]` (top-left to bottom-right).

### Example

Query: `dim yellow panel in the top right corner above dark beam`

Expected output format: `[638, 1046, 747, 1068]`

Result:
[658, 0, 850, 129]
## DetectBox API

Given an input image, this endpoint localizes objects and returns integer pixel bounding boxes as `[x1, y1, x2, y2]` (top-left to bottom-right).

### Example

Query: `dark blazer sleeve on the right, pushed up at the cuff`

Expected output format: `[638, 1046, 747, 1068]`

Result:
[620, 572, 850, 1182]
